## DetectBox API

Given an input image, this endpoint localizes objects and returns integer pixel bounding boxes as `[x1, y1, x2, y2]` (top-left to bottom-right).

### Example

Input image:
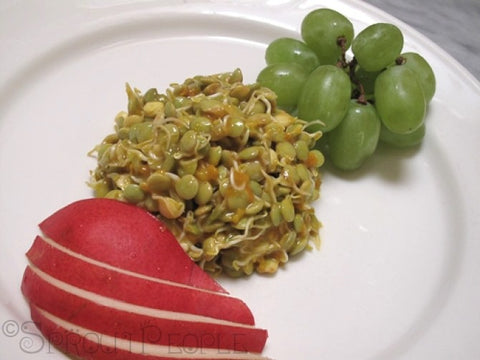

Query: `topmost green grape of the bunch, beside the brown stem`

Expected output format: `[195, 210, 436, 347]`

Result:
[301, 8, 354, 65]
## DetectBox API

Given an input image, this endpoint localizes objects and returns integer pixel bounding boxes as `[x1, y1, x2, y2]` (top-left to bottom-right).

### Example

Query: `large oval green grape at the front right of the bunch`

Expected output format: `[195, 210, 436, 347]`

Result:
[374, 65, 426, 134]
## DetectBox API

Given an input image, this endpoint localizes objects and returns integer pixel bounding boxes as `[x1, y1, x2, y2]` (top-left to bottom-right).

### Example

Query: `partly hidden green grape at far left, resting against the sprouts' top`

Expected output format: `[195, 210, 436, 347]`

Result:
[257, 63, 308, 110]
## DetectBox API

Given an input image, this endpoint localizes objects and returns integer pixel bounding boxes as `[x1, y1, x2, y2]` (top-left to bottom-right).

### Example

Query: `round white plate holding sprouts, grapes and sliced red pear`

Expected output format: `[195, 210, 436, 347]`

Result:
[0, 0, 480, 360]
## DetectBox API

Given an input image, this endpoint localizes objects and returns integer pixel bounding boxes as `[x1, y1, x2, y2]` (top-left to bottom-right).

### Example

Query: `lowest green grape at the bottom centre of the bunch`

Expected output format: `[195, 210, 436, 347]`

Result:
[326, 100, 380, 170]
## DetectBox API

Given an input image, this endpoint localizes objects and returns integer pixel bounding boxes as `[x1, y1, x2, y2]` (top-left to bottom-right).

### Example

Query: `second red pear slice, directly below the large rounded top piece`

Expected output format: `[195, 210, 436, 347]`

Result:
[27, 236, 254, 325]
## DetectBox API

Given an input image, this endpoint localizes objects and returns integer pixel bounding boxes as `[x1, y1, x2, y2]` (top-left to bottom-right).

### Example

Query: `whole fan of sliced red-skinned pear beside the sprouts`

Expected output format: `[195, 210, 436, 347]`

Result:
[21, 199, 268, 360]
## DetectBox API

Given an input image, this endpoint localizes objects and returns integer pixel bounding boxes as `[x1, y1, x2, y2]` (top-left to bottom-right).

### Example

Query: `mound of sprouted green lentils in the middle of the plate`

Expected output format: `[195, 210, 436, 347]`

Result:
[89, 69, 324, 276]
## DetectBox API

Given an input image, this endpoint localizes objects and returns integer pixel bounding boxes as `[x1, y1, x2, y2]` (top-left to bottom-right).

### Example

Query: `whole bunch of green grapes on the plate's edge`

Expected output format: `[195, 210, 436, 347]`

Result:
[257, 8, 435, 170]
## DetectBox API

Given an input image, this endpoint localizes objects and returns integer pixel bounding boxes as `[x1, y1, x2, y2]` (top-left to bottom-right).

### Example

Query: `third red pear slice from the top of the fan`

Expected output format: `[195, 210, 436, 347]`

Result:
[22, 267, 266, 353]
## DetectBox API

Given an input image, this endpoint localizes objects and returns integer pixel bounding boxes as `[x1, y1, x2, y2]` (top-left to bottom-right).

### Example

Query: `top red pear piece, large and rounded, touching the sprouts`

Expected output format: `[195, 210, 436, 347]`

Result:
[39, 198, 227, 293]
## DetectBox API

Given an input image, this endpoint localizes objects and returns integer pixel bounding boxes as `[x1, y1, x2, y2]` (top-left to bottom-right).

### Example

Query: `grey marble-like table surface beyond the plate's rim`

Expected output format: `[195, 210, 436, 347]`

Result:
[364, 0, 480, 80]
